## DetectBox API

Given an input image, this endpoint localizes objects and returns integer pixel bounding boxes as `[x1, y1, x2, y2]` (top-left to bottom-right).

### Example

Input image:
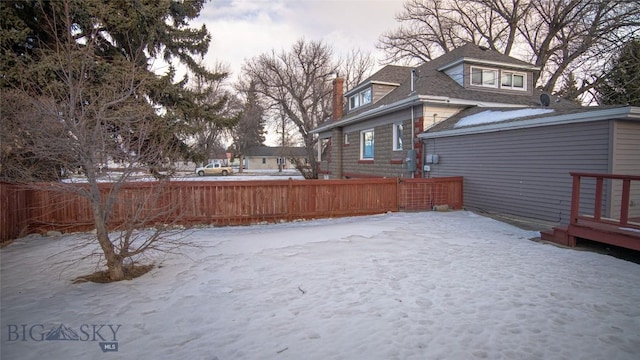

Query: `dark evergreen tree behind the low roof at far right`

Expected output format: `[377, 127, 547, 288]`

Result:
[595, 38, 640, 106]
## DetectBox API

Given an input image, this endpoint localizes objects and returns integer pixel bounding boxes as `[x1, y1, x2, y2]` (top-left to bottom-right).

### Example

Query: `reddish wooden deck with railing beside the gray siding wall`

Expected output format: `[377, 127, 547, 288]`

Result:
[541, 173, 640, 250]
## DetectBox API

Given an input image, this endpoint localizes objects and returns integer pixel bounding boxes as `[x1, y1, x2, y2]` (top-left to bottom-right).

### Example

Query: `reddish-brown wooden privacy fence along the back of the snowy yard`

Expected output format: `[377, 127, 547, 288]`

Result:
[0, 177, 463, 241]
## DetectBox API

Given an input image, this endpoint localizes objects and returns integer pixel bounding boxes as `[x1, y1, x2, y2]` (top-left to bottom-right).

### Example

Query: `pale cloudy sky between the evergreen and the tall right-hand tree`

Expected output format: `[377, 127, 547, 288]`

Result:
[193, 0, 403, 79]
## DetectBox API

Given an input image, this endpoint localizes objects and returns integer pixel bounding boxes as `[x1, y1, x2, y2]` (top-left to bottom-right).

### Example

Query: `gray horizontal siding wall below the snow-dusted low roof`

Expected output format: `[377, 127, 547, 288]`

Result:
[425, 121, 610, 223]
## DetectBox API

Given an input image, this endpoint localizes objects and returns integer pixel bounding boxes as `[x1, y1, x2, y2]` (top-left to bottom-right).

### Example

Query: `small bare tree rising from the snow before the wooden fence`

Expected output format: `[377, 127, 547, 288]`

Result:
[0, 1, 212, 281]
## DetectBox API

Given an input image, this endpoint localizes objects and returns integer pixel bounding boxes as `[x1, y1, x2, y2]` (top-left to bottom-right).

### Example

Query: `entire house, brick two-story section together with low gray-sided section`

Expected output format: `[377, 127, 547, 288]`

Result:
[314, 44, 640, 223]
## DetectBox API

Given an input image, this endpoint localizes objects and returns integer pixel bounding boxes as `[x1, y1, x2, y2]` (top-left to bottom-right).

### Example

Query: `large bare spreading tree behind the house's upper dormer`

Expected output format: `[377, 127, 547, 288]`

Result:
[378, 0, 640, 97]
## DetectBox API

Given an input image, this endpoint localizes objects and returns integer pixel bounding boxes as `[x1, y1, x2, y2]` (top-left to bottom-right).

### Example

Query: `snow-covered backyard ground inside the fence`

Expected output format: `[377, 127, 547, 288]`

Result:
[0, 211, 640, 360]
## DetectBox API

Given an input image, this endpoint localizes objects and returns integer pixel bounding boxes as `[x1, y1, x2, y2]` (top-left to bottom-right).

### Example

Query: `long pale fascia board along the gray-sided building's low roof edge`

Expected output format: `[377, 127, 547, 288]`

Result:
[418, 107, 640, 139]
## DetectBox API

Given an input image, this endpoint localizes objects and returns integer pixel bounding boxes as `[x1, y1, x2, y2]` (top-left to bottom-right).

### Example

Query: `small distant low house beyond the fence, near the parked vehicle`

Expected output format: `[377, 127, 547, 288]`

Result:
[244, 146, 308, 170]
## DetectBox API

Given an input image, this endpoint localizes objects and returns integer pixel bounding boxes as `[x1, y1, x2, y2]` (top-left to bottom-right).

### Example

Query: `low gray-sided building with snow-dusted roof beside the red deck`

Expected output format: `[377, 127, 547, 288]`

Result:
[418, 106, 640, 224]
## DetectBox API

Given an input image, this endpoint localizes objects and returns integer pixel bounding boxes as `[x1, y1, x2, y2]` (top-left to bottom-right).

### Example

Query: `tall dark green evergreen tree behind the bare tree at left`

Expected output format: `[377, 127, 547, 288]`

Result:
[0, 0, 227, 179]
